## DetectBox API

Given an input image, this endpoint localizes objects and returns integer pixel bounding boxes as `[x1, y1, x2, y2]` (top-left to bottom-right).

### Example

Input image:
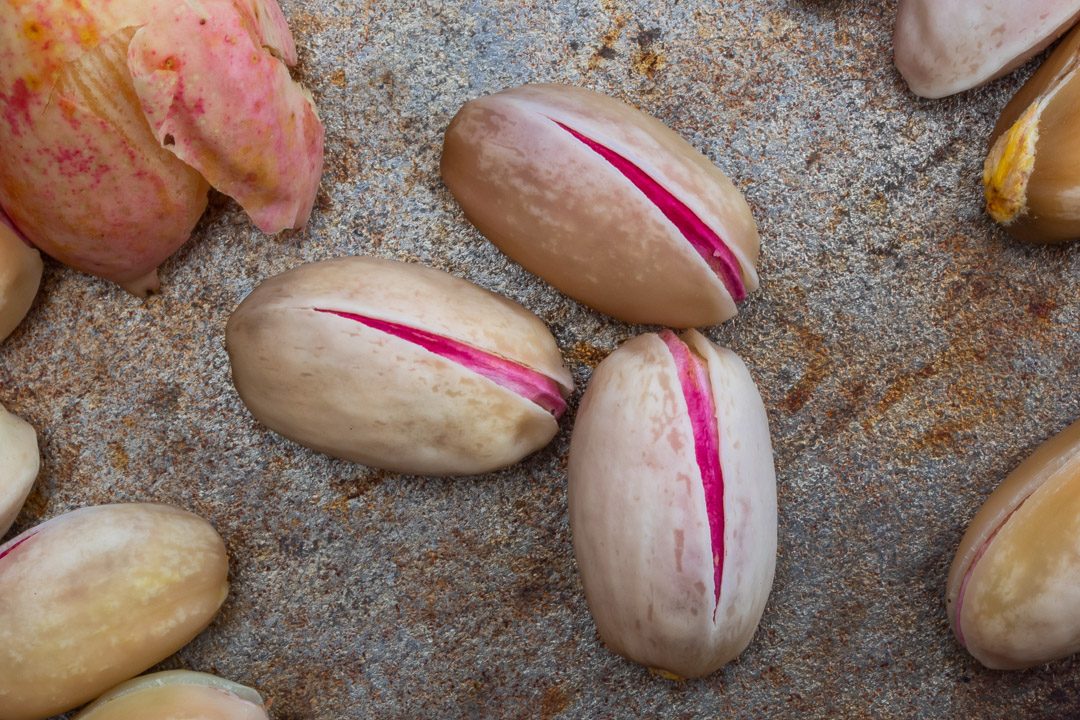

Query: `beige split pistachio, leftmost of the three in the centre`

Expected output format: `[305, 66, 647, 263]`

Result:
[226, 257, 573, 475]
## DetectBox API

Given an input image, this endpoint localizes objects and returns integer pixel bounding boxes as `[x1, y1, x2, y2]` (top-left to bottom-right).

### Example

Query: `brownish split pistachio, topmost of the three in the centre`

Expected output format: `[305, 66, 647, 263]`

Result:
[442, 85, 758, 327]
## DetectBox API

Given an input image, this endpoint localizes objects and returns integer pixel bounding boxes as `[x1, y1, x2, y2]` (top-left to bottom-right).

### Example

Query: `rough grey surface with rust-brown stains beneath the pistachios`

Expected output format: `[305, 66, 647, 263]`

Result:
[0, 0, 1080, 720]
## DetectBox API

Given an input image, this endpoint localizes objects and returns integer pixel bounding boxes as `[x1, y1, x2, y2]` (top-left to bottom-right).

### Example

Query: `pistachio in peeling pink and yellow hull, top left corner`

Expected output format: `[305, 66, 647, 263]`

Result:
[0, 0, 323, 295]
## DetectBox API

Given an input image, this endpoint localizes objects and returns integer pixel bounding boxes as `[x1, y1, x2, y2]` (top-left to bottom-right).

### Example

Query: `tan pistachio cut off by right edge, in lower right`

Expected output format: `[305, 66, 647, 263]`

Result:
[947, 421, 1080, 669]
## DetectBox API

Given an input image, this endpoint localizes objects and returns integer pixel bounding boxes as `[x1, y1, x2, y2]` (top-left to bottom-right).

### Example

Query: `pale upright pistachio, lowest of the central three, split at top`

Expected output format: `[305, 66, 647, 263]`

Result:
[569, 330, 777, 678]
